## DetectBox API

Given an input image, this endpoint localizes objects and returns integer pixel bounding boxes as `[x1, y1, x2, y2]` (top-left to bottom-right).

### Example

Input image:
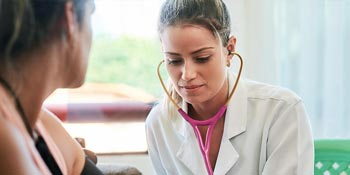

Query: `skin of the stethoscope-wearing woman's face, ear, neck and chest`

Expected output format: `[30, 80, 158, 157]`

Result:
[160, 24, 236, 168]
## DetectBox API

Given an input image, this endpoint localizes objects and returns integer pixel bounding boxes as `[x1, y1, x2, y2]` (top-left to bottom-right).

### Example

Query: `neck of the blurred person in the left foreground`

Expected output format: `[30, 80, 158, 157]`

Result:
[0, 47, 59, 131]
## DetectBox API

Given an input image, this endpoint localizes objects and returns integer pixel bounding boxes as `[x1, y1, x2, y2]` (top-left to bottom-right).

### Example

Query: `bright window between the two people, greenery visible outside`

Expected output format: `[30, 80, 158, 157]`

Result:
[45, 0, 162, 154]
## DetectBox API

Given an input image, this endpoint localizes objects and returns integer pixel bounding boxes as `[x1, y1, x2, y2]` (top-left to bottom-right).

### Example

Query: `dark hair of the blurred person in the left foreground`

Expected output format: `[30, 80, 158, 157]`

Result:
[0, 0, 89, 62]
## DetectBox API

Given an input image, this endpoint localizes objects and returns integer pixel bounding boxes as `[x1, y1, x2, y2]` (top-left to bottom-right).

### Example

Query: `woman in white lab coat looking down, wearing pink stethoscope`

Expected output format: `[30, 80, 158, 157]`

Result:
[146, 0, 314, 175]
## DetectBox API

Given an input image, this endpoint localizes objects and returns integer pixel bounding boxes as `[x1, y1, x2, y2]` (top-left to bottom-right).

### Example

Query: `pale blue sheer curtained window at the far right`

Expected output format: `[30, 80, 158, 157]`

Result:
[276, 0, 350, 138]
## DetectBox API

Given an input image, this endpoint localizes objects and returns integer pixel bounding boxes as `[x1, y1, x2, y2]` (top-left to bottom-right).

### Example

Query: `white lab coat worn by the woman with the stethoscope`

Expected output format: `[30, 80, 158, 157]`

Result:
[146, 73, 314, 175]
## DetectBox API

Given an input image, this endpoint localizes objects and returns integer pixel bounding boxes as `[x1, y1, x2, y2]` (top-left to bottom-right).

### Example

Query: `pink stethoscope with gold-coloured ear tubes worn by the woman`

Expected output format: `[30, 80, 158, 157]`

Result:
[157, 52, 243, 175]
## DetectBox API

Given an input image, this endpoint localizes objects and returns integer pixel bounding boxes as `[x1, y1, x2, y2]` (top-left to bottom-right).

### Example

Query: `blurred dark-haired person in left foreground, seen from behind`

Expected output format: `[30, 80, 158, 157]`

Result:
[0, 0, 102, 175]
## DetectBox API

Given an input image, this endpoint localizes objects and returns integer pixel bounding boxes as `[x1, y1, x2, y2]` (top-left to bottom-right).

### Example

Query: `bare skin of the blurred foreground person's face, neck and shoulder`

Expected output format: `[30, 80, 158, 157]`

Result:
[0, 2, 93, 175]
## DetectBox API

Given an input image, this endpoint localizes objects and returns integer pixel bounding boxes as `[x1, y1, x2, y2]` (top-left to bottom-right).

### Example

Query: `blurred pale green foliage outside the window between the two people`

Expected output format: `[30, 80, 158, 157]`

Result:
[86, 35, 164, 97]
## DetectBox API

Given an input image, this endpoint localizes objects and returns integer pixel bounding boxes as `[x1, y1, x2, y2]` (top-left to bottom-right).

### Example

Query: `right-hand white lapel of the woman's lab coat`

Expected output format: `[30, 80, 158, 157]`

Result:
[214, 72, 247, 174]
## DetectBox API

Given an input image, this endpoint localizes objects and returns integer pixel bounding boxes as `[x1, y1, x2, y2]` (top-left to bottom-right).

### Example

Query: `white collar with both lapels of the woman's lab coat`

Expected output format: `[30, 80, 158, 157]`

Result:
[172, 72, 247, 174]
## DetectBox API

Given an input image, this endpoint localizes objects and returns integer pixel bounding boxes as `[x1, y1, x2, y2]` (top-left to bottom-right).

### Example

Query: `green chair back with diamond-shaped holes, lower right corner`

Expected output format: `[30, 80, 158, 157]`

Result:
[314, 139, 350, 175]
